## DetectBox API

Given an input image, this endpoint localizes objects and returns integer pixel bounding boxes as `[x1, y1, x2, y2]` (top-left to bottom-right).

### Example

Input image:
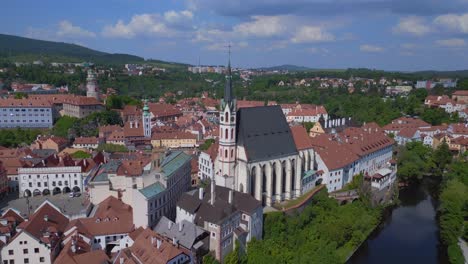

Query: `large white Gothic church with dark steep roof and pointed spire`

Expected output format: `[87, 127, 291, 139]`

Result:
[208, 55, 314, 206]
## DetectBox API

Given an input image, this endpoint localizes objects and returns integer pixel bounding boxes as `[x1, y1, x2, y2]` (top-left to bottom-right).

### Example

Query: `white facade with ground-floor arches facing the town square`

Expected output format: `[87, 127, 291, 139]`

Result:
[18, 166, 83, 197]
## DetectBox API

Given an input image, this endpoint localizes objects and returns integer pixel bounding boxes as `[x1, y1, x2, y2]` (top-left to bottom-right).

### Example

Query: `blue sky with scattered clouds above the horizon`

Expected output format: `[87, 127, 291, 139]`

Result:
[0, 0, 468, 71]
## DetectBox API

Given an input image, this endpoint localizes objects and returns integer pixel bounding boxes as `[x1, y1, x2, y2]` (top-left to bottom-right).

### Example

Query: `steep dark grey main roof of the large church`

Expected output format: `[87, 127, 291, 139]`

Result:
[237, 105, 297, 161]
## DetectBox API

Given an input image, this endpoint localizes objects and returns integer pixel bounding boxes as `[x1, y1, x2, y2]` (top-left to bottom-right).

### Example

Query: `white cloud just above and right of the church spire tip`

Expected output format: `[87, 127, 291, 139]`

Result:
[234, 16, 287, 37]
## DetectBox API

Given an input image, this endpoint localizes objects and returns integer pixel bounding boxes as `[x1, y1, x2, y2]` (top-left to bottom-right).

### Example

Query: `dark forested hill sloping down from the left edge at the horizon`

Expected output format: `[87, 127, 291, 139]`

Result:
[0, 34, 144, 64]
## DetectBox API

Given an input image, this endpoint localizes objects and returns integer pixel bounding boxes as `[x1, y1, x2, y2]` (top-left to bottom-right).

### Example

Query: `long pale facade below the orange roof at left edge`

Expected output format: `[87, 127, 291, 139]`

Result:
[0, 106, 54, 128]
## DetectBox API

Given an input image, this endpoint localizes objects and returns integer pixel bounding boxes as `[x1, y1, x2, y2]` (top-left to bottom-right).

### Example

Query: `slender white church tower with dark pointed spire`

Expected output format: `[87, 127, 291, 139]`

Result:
[216, 49, 237, 189]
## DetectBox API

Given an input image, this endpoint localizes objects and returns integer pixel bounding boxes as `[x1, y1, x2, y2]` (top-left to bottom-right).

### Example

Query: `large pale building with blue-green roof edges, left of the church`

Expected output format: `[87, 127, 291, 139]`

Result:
[88, 151, 191, 227]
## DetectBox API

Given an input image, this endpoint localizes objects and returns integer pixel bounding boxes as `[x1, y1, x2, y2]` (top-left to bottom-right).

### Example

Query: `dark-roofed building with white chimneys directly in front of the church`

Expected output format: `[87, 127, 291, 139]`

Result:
[176, 181, 263, 262]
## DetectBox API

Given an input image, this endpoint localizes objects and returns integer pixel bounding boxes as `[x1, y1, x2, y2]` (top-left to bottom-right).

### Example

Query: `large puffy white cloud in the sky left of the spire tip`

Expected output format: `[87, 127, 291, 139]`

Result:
[102, 10, 193, 39]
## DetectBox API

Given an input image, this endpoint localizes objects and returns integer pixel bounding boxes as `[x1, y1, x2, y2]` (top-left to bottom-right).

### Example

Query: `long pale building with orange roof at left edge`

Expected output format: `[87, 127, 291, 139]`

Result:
[0, 98, 54, 128]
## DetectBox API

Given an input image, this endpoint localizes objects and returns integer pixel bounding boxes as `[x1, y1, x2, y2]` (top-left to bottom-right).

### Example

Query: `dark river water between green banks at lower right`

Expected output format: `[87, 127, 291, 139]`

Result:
[348, 182, 448, 264]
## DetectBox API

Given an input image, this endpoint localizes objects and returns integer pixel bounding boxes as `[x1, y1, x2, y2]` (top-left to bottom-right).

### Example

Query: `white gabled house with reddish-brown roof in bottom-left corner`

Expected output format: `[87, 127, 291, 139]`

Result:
[1, 202, 68, 263]
